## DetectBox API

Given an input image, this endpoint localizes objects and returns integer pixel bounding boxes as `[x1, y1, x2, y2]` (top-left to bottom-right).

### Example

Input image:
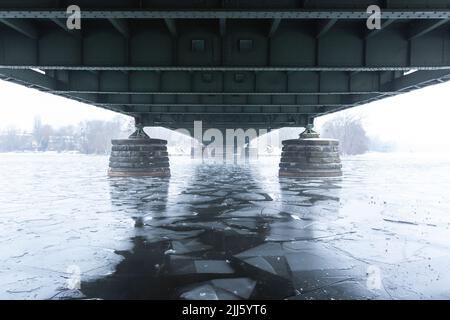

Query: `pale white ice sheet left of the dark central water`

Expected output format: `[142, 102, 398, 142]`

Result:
[0, 154, 139, 299]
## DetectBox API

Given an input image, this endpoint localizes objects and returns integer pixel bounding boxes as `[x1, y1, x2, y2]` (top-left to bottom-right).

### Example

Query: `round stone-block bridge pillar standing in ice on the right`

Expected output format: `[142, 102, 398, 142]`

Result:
[280, 138, 342, 178]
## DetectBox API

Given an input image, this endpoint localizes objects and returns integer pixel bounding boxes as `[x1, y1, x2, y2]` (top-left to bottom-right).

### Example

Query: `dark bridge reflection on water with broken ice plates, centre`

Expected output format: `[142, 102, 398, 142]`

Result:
[81, 163, 386, 300]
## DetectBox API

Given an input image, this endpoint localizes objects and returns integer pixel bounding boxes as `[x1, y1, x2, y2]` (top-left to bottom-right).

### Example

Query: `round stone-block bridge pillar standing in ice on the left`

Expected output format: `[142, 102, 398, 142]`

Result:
[108, 135, 170, 177]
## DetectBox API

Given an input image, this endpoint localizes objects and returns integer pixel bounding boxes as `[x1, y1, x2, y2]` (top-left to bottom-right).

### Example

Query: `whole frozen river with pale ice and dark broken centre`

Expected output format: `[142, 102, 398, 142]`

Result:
[0, 154, 450, 299]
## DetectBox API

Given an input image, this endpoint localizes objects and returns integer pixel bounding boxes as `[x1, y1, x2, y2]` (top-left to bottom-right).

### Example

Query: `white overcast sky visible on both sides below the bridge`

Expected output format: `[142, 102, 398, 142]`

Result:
[0, 81, 450, 151]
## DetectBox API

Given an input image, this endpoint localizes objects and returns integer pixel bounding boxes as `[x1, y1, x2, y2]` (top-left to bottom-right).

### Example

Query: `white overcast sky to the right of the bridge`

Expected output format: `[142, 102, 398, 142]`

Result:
[317, 82, 450, 151]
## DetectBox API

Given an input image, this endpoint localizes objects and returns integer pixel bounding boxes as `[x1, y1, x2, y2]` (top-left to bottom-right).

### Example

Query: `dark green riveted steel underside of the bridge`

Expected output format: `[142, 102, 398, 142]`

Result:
[0, 0, 450, 128]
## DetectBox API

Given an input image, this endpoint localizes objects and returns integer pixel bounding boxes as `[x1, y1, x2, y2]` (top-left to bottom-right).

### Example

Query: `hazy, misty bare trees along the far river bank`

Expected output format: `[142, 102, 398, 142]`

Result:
[0, 113, 395, 155]
